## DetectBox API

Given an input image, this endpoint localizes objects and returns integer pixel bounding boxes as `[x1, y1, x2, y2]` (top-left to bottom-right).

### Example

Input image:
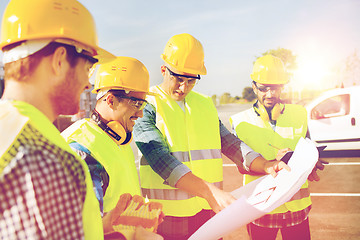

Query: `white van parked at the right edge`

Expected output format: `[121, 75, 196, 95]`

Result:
[305, 86, 360, 157]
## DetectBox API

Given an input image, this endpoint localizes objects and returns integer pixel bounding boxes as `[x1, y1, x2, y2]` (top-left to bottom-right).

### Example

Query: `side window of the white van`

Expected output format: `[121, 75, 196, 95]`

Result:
[311, 94, 350, 120]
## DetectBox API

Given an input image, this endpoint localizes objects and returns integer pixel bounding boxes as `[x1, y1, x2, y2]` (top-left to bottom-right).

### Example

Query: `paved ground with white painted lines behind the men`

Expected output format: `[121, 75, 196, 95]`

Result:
[218, 105, 360, 240]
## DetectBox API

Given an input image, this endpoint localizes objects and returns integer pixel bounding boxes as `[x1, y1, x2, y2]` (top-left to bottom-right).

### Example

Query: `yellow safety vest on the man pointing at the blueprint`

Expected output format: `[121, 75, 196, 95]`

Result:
[140, 86, 223, 217]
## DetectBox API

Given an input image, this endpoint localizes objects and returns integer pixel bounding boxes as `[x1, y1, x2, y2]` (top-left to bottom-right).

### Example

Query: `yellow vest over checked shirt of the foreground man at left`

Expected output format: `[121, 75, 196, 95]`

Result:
[0, 101, 104, 240]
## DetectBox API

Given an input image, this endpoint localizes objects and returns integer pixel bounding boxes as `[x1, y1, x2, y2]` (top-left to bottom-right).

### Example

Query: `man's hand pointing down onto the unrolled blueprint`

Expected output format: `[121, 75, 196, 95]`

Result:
[205, 183, 236, 213]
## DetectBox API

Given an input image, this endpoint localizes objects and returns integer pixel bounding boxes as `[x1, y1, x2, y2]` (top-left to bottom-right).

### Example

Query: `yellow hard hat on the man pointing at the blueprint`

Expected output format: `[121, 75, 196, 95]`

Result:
[161, 33, 206, 75]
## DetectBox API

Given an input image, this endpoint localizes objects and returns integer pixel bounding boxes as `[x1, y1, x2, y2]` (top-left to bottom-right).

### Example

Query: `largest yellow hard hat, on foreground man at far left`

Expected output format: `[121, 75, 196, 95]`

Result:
[0, 0, 115, 62]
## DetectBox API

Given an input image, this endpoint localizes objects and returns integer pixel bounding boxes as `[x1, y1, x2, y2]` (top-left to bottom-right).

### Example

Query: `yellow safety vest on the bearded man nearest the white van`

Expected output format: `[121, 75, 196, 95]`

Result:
[230, 104, 311, 214]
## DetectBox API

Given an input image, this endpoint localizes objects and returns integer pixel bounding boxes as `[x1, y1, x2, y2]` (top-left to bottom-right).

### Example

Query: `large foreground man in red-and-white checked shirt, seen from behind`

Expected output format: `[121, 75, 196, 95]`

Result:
[0, 0, 113, 240]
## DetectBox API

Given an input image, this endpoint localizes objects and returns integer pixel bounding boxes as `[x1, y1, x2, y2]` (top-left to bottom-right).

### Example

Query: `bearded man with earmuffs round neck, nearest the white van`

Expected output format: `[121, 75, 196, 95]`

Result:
[230, 55, 326, 240]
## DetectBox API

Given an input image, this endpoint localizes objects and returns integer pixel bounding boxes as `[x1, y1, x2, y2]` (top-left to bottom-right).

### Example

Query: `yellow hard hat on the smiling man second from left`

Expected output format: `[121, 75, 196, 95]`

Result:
[92, 57, 150, 94]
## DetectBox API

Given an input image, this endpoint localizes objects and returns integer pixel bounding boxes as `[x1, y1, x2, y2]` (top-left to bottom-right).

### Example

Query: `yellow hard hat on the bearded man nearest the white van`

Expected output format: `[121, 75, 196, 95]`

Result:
[250, 55, 289, 84]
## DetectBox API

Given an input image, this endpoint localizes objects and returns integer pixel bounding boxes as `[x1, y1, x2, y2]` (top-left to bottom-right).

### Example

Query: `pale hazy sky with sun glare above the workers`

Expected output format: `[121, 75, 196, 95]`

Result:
[0, 0, 360, 96]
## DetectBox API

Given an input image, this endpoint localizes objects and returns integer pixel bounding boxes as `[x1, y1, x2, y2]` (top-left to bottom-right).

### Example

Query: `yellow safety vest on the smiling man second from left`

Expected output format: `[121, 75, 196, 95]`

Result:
[61, 119, 141, 212]
